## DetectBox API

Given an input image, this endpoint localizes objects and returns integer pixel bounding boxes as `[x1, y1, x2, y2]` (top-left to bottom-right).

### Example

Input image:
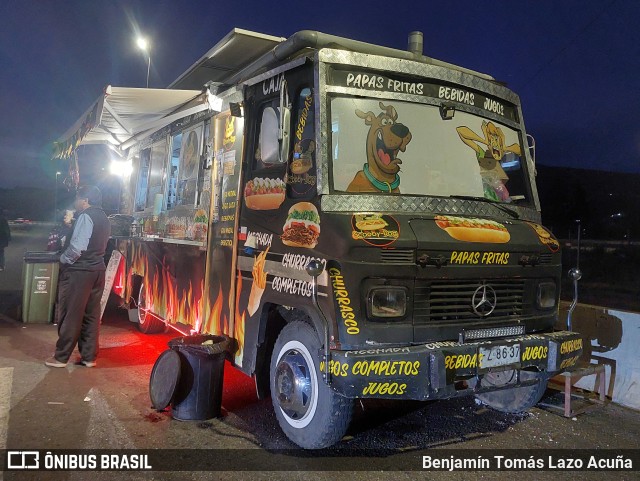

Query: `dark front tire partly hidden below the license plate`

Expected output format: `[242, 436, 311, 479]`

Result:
[476, 370, 549, 413]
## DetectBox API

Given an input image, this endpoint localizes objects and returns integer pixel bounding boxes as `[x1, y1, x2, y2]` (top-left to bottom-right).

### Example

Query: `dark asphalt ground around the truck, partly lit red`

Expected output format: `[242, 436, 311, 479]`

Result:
[0, 226, 640, 481]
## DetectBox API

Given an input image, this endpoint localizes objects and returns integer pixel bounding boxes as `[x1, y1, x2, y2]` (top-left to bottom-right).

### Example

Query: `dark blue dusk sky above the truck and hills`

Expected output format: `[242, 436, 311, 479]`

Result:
[0, 0, 640, 188]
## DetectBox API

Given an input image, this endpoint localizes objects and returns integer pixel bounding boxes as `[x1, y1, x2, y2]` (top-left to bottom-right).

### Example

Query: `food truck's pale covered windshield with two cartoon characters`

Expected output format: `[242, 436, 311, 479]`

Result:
[330, 97, 530, 203]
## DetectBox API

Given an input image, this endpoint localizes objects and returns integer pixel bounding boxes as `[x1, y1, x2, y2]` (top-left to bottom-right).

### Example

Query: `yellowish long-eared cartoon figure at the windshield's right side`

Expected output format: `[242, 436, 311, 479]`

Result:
[456, 120, 521, 180]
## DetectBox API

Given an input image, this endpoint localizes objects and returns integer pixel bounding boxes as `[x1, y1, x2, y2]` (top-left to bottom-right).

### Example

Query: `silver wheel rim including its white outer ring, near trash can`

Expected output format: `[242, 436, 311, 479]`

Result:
[275, 341, 318, 428]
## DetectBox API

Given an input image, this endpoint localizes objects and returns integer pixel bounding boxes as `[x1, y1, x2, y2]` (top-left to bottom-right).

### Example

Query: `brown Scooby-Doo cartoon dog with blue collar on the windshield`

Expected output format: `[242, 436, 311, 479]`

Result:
[347, 102, 411, 194]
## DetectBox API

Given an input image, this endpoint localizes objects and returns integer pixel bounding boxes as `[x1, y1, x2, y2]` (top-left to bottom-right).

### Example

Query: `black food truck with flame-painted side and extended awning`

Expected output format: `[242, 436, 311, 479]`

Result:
[58, 29, 582, 449]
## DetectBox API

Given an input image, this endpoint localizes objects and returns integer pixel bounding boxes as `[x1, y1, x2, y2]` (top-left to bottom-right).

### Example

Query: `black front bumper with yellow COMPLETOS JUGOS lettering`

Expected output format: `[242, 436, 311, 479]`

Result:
[328, 331, 582, 400]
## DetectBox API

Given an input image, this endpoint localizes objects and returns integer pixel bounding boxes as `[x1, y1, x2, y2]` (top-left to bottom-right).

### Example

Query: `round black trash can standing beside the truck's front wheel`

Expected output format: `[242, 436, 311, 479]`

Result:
[169, 335, 230, 421]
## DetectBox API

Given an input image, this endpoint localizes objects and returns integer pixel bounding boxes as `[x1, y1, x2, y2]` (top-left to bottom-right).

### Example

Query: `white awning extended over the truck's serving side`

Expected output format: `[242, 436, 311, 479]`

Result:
[53, 85, 212, 158]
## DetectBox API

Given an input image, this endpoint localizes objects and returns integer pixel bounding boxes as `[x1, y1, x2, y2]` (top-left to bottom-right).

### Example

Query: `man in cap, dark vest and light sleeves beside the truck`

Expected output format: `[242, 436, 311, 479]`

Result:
[45, 185, 111, 367]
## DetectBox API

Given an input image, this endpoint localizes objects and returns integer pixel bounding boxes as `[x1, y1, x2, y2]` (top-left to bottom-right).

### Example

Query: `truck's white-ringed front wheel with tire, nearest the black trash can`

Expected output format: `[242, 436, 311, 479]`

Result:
[270, 321, 353, 449]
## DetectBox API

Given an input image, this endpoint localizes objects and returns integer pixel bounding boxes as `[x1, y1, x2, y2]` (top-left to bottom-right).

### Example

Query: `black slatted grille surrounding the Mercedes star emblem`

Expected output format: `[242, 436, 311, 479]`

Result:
[413, 279, 525, 324]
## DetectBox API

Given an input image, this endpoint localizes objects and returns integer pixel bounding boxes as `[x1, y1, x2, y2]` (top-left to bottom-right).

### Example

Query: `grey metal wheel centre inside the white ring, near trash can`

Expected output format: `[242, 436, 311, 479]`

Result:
[275, 349, 313, 421]
